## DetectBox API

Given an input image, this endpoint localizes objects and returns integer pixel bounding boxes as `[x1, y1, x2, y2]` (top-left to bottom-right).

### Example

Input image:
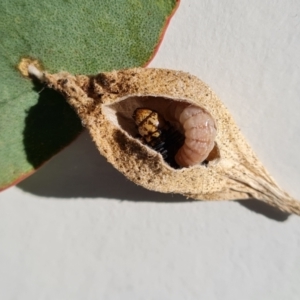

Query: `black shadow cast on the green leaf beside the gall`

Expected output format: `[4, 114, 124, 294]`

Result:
[23, 83, 82, 168]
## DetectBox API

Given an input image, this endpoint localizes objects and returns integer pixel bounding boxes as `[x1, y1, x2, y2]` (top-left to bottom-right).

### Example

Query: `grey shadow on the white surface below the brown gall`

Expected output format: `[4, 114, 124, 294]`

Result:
[18, 127, 289, 221]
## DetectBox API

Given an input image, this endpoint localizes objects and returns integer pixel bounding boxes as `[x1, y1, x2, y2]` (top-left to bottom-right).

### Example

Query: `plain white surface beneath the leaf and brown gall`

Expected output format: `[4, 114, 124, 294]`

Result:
[0, 0, 300, 300]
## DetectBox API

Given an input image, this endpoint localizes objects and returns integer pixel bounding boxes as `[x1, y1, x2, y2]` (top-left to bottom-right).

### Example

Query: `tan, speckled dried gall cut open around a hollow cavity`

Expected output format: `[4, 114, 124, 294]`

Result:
[28, 68, 300, 215]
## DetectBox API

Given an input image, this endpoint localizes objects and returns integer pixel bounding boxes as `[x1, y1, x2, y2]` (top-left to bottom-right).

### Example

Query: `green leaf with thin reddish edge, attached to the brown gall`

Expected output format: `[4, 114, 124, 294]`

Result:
[0, 0, 179, 190]
